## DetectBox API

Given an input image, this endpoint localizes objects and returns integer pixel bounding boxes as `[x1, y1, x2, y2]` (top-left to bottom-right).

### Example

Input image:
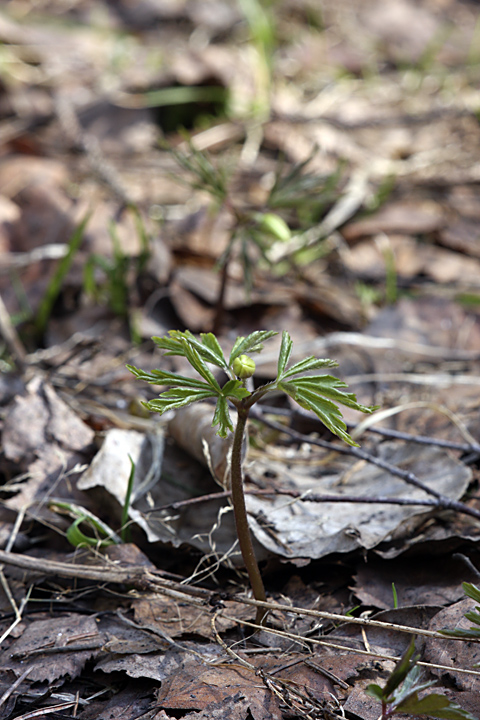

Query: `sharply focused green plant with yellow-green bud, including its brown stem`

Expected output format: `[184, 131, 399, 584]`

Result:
[127, 330, 376, 624]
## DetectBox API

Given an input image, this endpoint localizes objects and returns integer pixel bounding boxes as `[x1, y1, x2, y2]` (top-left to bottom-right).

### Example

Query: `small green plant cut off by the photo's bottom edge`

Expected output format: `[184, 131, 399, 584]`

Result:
[365, 638, 475, 720]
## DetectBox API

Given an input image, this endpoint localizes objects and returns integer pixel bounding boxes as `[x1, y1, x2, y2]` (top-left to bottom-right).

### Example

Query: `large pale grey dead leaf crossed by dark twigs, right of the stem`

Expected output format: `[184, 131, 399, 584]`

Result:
[246, 442, 471, 558]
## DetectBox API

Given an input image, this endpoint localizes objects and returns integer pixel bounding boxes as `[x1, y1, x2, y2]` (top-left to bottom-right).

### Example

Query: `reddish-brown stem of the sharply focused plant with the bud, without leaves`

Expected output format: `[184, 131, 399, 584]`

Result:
[230, 403, 267, 625]
